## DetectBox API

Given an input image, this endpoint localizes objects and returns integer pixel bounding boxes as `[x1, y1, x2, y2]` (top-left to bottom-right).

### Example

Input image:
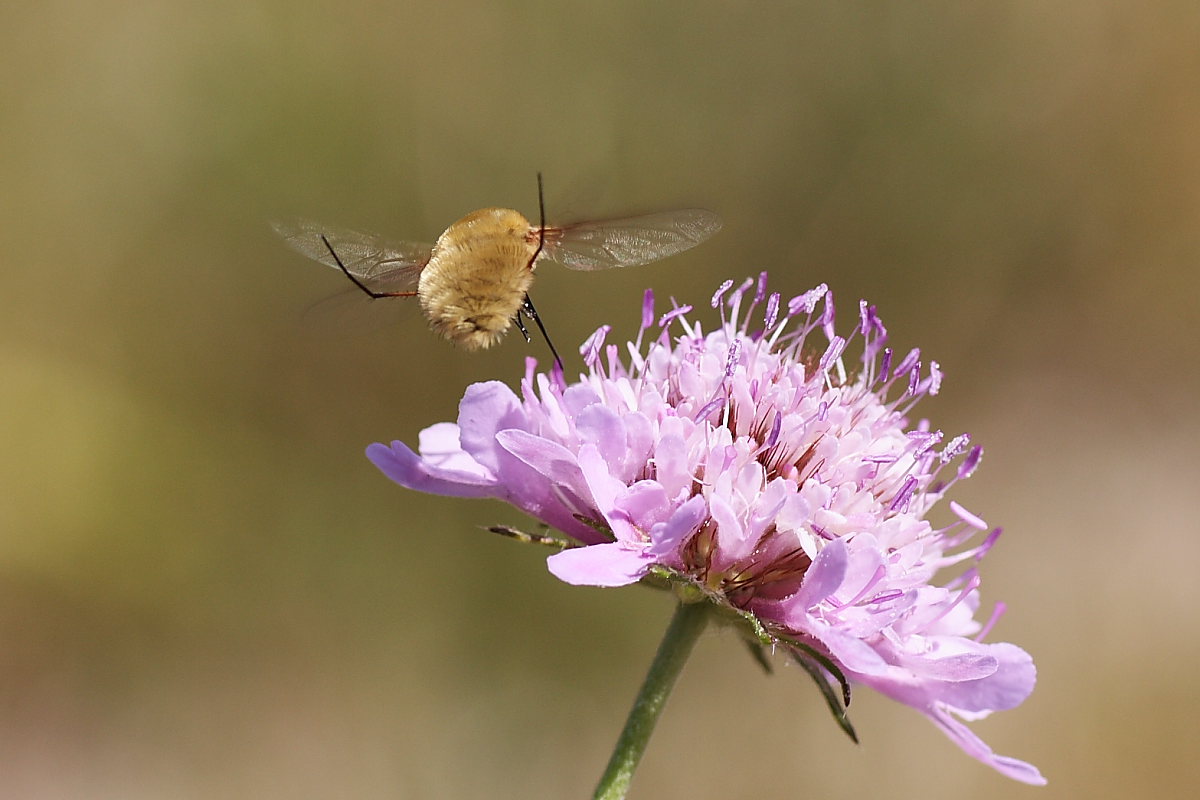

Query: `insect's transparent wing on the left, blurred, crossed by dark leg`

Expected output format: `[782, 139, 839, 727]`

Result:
[271, 219, 433, 290]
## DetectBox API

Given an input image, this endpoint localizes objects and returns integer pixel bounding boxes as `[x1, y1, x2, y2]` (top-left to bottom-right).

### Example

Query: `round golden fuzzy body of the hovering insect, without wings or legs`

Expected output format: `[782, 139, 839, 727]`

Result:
[416, 209, 538, 350]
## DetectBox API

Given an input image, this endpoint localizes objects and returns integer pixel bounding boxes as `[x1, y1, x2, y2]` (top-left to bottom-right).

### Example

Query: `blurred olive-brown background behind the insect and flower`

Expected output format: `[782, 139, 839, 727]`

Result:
[0, 0, 1200, 799]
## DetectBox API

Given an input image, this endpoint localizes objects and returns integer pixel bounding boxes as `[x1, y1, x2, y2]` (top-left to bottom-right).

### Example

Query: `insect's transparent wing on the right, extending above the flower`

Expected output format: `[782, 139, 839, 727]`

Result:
[534, 209, 721, 270]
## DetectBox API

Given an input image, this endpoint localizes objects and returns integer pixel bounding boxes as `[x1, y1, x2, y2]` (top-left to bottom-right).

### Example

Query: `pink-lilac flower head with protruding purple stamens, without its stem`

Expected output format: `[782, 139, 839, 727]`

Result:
[367, 273, 1044, 783]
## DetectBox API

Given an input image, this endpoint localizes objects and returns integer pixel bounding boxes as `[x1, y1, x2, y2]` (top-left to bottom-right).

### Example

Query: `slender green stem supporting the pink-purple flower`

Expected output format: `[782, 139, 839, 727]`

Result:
[592, 602, 710, 800]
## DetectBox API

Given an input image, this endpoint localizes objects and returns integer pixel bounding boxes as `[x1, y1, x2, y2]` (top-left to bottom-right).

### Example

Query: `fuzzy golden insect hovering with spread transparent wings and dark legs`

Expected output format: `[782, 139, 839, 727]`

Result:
[272, 174, 721, 363]
